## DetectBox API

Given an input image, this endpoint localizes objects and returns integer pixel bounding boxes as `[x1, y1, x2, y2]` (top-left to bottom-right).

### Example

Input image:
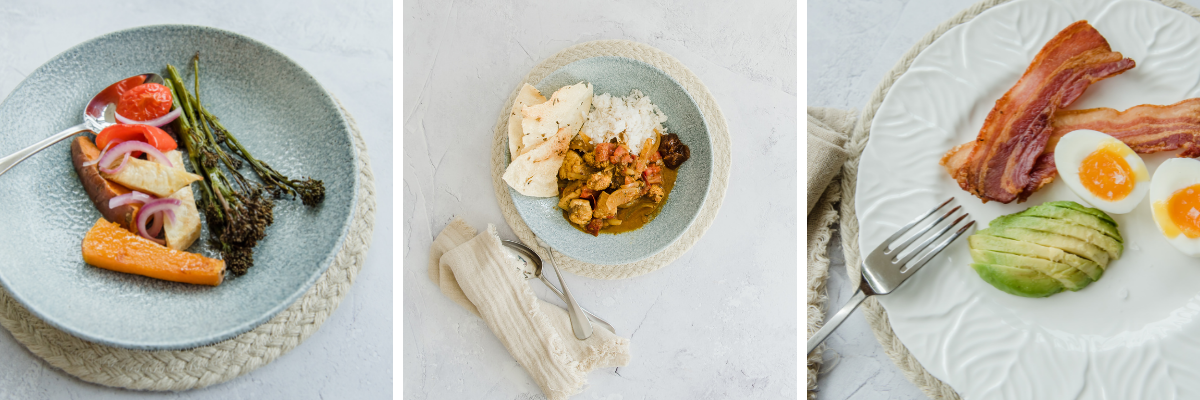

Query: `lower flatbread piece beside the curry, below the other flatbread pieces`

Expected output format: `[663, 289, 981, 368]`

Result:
[504, 127, 578, 197]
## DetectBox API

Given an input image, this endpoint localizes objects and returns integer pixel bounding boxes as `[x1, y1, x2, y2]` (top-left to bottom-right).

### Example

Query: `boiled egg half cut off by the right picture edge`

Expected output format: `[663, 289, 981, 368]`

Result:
[1150, 159, 1200, 257]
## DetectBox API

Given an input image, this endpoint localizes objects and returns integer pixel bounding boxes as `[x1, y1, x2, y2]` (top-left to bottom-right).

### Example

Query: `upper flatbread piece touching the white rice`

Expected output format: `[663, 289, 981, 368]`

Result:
[521, 83, 592, 151]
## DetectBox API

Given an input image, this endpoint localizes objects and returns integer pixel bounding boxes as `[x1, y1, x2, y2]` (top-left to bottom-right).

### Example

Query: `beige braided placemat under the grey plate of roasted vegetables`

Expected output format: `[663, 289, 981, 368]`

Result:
[0, 103, 376, 390]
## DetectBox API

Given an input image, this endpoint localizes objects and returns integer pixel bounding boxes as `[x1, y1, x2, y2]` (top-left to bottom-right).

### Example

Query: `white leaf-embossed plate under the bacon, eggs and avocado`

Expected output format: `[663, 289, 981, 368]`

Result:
[854, 0, 1200, 399]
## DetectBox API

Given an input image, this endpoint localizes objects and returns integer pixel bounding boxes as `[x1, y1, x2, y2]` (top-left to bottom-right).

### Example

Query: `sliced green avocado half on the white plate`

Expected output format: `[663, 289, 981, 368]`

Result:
[968, 199, 1118, 297]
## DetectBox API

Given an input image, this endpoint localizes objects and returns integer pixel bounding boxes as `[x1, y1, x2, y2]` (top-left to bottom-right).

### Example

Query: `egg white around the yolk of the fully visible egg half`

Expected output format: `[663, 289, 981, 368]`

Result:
[1054, 130, 1150, 214]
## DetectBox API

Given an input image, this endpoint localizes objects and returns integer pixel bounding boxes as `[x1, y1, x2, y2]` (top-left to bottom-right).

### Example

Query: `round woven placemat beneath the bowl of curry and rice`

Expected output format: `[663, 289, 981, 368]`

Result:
[492, 40, 732, 279]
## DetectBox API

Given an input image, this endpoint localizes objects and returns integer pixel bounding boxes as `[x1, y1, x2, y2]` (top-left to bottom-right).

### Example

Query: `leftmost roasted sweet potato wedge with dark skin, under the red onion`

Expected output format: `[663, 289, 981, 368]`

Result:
[71, 136, 138, 231]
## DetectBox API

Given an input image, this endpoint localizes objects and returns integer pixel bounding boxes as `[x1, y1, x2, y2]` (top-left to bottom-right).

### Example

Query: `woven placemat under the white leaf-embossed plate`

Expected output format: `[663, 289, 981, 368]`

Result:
[840, 0, 1200, 399]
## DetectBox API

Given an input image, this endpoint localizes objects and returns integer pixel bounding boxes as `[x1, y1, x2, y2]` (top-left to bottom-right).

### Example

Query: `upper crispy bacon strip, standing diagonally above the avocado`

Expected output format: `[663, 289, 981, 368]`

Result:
[942, 20, 1134, 203]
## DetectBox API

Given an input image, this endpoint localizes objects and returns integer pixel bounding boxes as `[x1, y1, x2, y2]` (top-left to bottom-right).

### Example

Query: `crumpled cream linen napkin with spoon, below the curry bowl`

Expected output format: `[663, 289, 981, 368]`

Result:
[430, 217, 630, 400]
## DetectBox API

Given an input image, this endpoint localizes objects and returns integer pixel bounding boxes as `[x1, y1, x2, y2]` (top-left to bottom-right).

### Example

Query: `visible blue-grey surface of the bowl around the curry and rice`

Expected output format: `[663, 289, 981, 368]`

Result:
[505, 56, 713, 265]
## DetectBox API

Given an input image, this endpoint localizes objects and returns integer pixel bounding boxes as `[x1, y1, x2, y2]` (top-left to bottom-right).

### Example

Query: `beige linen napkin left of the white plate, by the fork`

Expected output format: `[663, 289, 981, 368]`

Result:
[805, 107, 857, 399]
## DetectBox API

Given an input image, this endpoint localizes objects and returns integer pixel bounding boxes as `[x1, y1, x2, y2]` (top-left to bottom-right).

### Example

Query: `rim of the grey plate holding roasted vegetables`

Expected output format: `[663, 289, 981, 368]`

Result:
[0, 24, 362, 351]
